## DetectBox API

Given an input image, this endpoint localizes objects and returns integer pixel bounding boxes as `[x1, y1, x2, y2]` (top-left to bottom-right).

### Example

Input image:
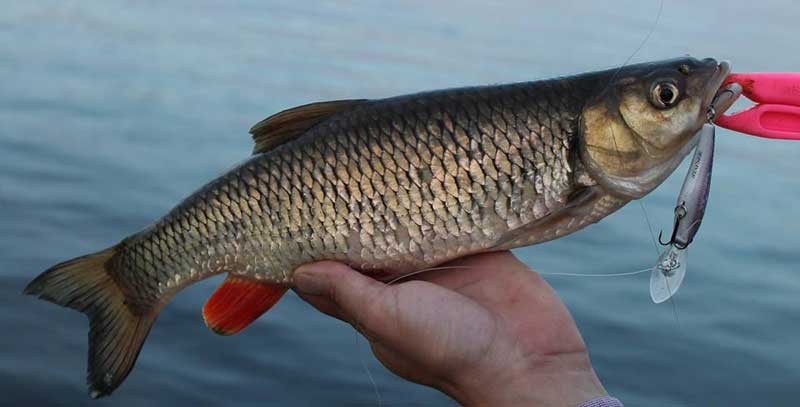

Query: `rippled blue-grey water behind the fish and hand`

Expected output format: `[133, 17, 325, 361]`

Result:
[0, 0, 800, 406]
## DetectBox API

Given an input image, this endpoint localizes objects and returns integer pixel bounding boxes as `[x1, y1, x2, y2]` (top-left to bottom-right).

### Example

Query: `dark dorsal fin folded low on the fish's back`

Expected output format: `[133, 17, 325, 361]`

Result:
[250, 99, 367, 154]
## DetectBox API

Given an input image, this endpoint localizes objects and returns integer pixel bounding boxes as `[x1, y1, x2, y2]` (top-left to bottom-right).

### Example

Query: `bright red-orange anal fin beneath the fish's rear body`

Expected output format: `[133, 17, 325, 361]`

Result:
[203, 275, 288, 335]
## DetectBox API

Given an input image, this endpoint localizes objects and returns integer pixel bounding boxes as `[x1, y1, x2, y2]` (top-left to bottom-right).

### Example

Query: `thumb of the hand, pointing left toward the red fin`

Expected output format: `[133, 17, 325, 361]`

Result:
[294, 261, 393, 336]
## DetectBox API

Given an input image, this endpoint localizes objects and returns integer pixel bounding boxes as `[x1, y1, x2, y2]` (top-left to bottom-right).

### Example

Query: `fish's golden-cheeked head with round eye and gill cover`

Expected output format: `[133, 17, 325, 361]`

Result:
[579, 57, 730, 199]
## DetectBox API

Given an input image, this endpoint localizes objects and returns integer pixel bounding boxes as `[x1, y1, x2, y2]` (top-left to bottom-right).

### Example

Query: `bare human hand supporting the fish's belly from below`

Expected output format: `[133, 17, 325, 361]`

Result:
[294, 251, 606, 406]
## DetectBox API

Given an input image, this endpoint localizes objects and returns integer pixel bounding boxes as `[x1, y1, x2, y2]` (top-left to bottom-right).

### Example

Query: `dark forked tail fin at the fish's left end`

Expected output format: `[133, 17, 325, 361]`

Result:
[24, 246, 157, 398]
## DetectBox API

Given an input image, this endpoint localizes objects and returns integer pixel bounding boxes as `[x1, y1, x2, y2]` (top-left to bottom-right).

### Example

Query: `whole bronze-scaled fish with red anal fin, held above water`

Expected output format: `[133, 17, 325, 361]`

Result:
[24, 57, 730, 398]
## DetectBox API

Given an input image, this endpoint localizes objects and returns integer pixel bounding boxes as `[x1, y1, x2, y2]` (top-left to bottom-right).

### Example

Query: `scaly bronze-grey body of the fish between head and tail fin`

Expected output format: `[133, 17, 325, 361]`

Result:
[114, 79, 588, 306]
